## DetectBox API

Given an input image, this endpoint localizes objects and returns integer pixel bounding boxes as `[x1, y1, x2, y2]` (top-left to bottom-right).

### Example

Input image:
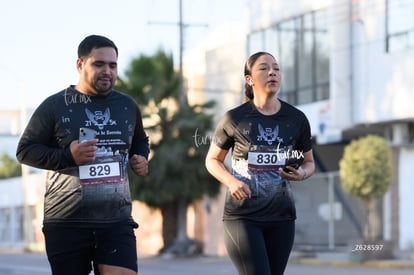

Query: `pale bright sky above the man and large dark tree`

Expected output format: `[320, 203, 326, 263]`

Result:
[0, 0, 246, 110]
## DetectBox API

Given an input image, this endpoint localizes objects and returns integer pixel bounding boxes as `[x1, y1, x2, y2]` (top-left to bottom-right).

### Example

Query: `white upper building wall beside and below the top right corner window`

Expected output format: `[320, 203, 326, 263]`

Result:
[351, 1, 414, 124]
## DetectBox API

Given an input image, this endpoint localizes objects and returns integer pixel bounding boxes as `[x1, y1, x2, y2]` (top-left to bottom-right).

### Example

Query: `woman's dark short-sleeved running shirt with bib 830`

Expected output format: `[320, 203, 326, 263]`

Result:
[213, 100, 312, 222]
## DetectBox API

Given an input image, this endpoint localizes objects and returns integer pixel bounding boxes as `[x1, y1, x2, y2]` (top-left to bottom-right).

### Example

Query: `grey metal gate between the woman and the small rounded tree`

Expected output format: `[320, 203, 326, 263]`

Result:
[292, 172, 365, 250]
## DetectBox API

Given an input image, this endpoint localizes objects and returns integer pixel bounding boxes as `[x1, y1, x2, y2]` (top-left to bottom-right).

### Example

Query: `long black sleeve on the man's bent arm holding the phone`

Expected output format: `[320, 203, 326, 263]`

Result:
[16, 98, 76, 171]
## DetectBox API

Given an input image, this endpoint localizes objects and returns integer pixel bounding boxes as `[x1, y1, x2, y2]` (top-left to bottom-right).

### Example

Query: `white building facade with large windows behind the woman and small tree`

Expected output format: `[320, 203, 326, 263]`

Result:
[192, 0, 414, 257]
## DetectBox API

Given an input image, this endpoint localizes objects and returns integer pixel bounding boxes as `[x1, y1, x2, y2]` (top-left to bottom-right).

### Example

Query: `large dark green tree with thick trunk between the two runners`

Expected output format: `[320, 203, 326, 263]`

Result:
[116, 50, 220, 254]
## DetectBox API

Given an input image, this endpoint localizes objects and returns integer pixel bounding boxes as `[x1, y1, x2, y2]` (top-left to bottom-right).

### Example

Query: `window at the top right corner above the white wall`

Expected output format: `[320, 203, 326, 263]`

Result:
[386, 0, 414, 52]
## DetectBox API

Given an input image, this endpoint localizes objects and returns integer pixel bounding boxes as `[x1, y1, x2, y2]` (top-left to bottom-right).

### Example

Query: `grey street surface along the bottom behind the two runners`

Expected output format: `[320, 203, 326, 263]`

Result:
[0, 253, 414, 275]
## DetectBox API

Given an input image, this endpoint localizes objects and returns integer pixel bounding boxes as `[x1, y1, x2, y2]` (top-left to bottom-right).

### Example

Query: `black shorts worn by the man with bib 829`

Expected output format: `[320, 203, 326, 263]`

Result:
[43, 224, 138, 275]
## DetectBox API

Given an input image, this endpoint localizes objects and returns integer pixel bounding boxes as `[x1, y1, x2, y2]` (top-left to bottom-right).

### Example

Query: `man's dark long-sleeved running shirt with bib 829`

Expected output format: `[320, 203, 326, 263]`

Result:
[17, 87, 149, 227]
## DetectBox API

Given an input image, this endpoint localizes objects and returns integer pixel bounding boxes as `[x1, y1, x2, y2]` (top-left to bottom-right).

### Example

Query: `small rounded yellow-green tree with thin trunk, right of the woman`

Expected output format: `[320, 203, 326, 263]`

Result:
[339, 135, 392, 241]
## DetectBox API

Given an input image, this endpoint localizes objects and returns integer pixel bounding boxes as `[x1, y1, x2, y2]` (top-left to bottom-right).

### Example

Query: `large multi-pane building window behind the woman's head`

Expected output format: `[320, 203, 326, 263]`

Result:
[247, 10, 329, 105]
